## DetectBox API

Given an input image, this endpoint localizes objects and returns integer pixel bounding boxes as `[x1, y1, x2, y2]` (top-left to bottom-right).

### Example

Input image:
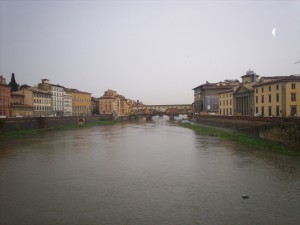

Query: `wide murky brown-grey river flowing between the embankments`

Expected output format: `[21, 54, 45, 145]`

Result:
[0, 118, 300, 225]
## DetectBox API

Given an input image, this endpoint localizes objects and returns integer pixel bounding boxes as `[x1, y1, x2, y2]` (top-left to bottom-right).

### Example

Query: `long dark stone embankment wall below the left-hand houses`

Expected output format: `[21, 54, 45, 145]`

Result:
[0, 115, 113, 133]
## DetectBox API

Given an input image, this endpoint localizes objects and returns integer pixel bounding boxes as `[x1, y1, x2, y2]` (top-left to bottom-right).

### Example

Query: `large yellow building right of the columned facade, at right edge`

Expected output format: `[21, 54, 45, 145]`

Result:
[253, 75, 300, 117]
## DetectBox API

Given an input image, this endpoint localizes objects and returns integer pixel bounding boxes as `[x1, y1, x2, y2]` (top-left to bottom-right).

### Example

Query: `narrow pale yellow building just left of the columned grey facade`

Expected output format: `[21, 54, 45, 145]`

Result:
[219, 88, 234, 116]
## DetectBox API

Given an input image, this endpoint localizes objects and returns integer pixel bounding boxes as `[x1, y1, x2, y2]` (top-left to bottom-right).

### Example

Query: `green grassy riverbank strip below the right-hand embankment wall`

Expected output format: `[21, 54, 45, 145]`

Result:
[178, 122, 300, 156]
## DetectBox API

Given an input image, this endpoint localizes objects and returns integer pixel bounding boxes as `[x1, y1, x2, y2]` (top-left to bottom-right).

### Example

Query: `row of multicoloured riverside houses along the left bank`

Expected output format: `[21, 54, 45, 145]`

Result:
[0, 76, 135, 117]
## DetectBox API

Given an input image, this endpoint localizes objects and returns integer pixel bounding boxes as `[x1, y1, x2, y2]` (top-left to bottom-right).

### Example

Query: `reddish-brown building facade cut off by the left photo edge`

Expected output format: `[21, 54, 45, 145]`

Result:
[0, 76, 11, 117]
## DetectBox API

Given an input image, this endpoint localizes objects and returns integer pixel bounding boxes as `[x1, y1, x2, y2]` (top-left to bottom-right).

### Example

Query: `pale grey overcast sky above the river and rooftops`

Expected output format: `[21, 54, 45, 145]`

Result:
[0, 0, 300, 104]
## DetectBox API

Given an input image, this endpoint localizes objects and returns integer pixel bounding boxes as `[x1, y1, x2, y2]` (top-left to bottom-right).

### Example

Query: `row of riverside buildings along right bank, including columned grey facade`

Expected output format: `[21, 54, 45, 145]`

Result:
[193, 70, 300, 117]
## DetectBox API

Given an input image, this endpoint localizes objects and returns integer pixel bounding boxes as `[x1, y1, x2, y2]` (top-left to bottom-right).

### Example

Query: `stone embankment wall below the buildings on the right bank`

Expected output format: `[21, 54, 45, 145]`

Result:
[194, 115, 300, 151]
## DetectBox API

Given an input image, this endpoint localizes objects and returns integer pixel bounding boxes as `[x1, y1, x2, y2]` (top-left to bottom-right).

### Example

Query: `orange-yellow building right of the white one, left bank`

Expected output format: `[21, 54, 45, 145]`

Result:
[65, 88, 92, 116]
